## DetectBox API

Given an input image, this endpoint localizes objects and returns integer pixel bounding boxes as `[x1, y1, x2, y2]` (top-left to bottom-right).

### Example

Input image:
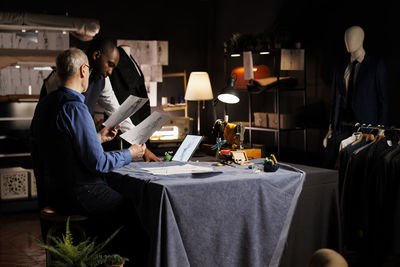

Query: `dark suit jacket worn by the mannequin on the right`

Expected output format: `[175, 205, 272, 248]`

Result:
[330, 55, 389, 130]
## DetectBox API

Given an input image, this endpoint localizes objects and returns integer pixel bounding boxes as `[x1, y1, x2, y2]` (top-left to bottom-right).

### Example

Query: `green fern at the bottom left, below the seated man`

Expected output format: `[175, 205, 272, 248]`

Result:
[35, 217, 122, 267]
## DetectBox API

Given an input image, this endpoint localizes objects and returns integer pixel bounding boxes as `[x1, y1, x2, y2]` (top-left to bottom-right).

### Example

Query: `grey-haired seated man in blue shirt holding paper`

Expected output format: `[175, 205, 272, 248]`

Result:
[31, 48, 146, 215]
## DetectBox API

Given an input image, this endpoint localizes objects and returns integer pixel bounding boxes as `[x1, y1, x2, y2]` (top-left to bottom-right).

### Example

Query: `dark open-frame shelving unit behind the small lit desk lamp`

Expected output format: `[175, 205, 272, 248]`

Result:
[225, 49, 307, 157]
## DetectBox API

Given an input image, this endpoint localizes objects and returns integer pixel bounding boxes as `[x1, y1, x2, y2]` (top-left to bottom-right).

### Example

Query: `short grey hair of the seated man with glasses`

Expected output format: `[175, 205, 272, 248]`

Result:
[56, 47, 89, 82]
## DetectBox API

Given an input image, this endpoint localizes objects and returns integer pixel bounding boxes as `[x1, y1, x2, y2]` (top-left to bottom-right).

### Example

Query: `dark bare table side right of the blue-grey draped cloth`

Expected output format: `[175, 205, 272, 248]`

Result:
[280, 164, 342, 267]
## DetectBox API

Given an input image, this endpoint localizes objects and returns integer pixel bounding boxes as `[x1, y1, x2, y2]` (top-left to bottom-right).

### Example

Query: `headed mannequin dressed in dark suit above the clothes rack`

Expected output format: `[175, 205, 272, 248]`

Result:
[323, 26, 388, 168]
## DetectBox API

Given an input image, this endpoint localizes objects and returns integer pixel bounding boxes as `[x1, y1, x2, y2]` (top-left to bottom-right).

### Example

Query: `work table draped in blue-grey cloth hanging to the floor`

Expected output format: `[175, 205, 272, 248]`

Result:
[110, 160, 305, 267]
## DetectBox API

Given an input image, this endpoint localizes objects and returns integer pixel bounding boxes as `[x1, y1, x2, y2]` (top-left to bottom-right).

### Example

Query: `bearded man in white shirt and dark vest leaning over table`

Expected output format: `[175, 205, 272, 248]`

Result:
[41, 38, 160, 161]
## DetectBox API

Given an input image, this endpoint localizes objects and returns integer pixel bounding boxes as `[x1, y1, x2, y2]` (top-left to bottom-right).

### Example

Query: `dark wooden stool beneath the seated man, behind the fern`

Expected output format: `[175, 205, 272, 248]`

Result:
[40, 207, 88, 266]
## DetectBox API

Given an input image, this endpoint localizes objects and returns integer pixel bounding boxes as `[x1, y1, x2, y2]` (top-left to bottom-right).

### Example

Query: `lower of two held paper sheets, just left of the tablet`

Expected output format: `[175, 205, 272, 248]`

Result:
[120, 111, 170, 145]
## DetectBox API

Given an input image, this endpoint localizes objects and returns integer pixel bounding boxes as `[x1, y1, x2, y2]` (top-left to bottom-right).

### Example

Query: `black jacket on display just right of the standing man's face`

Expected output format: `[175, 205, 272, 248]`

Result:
[110, 47, 151, 125]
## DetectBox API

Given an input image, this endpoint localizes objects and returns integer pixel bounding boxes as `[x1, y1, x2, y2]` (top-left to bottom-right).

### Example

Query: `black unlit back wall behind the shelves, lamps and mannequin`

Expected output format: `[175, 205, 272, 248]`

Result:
[0, 0, 400, 168]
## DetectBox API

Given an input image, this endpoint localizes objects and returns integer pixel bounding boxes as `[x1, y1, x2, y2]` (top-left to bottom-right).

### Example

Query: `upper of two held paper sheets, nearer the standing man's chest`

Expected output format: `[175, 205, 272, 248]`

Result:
[103, 95, 149, 127]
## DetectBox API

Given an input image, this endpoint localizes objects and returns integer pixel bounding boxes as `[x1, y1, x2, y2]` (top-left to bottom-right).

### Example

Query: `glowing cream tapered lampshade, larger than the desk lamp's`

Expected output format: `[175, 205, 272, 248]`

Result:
[185, 72, 214, 100]
